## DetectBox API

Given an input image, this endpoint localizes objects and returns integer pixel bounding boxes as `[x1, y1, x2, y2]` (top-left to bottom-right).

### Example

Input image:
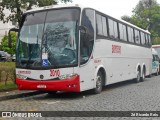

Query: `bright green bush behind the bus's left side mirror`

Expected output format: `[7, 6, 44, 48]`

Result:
[1, 32, 17, 55]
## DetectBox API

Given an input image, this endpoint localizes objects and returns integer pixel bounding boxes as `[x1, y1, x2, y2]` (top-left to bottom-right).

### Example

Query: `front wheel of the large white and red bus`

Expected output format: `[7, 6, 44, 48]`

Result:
[93, 71, 103, 94]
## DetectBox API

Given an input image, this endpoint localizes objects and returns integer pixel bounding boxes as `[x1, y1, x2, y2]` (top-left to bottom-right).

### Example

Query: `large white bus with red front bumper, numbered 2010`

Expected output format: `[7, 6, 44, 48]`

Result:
[10, 5, 152, 93]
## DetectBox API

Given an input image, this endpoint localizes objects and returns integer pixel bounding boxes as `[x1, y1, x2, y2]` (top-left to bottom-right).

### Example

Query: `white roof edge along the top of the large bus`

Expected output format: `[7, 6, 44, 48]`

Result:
[24, 4, 150, 34]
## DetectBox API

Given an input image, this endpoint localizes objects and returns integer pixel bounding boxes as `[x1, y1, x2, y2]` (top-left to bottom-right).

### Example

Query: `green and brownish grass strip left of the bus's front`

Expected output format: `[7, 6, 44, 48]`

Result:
[0, 62, 17, 91]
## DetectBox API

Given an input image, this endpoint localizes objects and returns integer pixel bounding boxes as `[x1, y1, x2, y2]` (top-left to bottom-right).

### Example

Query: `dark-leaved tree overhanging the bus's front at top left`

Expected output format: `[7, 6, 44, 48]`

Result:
[0, 0, 72, 25]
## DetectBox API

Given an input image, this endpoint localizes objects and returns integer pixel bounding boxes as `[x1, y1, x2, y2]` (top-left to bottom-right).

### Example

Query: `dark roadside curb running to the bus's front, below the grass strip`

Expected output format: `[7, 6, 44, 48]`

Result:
[0, 91, 44, 101]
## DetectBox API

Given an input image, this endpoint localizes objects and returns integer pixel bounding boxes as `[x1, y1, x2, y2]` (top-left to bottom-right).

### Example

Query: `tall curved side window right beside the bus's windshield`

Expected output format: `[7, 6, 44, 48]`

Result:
[80, 9, 94, 64]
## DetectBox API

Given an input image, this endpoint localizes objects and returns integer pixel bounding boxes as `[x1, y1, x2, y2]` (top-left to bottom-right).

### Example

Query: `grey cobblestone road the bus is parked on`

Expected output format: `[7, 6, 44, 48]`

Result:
[0, 76, 160, 120]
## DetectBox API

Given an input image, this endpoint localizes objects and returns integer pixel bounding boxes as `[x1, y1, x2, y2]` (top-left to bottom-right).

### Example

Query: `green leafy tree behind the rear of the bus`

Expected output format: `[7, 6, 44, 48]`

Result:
[121, 0, 160, 44]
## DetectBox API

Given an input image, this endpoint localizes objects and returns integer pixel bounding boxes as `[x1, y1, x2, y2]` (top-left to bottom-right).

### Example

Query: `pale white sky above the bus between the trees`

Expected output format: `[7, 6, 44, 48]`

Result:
[72, 0, 160, 18]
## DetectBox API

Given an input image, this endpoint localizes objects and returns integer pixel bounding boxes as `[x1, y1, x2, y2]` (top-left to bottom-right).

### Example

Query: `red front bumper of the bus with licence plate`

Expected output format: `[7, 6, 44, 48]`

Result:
[16, 75, 80, 92]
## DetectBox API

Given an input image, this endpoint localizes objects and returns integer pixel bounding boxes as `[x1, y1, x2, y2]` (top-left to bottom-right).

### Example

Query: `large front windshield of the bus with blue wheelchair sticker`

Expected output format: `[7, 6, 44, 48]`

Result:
[16, 8, 80, 68]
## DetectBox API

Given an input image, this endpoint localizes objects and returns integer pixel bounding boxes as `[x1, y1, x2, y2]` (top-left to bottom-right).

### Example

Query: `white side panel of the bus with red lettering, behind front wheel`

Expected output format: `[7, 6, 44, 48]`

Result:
[94, 39, 152, 84]
